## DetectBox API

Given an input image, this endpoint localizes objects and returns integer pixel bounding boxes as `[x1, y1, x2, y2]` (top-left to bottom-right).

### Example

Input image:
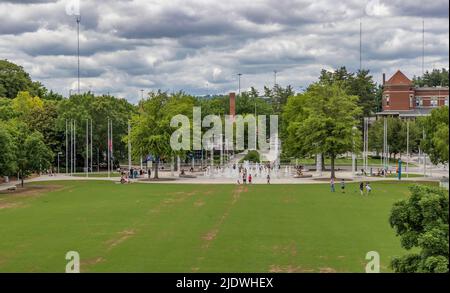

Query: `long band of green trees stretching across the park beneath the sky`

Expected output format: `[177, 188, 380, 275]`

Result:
[0, 60, 448, 177]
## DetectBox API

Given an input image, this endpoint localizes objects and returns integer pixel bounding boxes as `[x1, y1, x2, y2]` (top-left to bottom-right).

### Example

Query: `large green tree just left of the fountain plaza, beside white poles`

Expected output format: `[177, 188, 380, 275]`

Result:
[129, 91, 194, 178]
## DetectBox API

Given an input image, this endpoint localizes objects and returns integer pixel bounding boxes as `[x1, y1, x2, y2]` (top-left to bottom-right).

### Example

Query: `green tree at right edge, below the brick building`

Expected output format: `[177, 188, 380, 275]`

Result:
[421, 106, 449, 164]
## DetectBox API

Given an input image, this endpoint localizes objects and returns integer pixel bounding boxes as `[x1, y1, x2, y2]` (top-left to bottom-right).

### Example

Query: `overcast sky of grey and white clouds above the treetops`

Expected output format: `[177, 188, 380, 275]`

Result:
[0, 0, 449, 102]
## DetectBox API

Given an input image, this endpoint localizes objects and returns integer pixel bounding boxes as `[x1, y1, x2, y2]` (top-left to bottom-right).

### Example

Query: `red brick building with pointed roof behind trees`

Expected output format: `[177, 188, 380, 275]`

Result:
[377, 70, 448, 118]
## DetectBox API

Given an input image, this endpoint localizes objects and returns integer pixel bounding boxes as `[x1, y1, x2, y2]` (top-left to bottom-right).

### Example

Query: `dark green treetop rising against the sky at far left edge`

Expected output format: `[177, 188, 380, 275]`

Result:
[0, 60, 33, 99]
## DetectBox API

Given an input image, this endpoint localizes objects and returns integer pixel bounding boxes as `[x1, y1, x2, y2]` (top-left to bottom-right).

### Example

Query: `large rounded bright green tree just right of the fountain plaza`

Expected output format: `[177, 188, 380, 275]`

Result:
[288, 83, 361, 178]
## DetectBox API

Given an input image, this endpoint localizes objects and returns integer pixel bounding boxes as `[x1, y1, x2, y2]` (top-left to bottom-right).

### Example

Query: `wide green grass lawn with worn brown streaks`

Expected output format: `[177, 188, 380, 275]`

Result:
[0, 181, 432, 272]
